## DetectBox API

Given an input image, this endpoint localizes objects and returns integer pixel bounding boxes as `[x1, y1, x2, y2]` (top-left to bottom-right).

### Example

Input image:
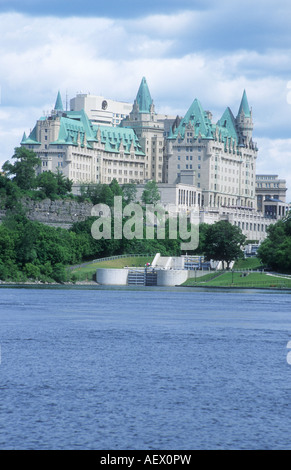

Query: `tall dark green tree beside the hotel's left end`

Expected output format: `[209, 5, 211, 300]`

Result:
[2, 147, 41, 190]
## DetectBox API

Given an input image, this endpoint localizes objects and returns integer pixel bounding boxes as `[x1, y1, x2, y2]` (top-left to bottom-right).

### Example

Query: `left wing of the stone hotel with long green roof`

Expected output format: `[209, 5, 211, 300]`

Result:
[21, 93, 145, 184]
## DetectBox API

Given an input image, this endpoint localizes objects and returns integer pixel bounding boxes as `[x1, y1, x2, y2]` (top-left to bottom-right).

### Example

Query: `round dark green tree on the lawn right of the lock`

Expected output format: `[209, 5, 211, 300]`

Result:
[204, 220, 246, 269]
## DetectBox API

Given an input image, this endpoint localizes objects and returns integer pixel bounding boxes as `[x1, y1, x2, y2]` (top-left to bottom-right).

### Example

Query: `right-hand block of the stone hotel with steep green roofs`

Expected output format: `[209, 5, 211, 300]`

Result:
[166, 94, 257, 208]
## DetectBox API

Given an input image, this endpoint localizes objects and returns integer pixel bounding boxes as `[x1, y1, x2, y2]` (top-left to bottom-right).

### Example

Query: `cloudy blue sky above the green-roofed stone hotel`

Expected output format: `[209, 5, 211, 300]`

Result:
[0, 0, 291, 202]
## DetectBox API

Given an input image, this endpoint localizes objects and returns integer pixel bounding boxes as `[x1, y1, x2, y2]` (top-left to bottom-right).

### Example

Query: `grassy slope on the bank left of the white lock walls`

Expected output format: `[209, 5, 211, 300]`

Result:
[70, 256, 153, 281]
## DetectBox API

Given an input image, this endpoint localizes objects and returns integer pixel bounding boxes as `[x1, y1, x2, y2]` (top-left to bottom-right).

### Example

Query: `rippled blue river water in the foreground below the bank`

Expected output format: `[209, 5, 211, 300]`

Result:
[0, 288, 291, 450]
